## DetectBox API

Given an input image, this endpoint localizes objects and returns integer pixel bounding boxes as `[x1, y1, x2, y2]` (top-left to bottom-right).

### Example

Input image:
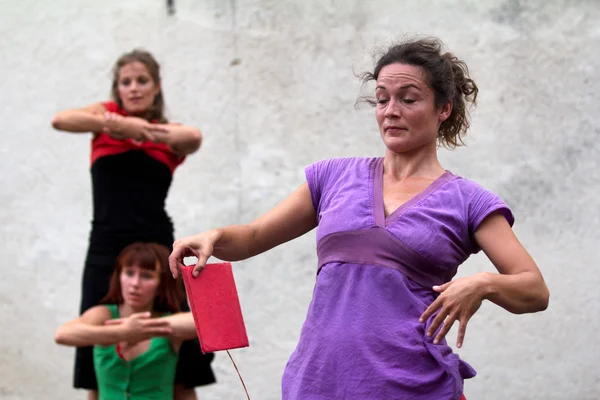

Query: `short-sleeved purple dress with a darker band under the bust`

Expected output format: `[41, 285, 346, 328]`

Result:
[282, 158, 513, 400]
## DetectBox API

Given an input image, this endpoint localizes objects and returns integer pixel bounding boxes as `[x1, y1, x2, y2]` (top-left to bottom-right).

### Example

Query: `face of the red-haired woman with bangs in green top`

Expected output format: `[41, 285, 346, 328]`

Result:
[120, 265, 160, 310]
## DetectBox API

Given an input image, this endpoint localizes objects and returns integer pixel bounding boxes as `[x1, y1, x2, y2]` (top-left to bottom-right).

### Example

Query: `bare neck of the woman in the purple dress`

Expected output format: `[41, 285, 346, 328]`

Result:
[383, 142, 445, 181]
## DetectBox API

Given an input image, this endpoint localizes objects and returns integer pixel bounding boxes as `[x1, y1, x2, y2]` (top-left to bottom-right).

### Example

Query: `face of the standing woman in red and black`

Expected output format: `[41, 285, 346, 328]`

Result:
[117, 61, 160, 115]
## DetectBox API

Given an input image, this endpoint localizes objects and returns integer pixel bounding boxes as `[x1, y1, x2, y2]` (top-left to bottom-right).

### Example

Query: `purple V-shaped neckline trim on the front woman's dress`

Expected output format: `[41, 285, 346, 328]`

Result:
[373, 158, 454, 228]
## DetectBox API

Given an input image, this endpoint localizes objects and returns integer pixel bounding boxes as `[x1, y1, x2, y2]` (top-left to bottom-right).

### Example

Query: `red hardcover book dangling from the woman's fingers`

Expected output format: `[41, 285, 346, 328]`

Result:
[181, 262, 249, 354]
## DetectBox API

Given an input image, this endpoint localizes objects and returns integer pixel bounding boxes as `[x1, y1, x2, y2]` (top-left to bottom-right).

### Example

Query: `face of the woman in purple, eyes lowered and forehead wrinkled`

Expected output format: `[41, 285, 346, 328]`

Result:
[375, 63, 452, 153]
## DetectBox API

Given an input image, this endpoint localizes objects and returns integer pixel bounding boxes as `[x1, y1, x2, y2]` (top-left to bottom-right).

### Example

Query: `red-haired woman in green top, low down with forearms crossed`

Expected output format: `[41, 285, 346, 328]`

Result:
[55, 243, 196, 400]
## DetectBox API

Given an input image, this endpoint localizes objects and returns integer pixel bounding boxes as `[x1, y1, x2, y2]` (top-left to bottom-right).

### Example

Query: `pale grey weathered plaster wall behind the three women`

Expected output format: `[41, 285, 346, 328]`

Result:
[0, 0, 600, 400]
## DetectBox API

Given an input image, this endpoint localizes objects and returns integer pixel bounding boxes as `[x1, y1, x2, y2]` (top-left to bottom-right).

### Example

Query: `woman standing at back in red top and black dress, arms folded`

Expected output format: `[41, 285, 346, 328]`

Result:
[52, 50, 215, 400]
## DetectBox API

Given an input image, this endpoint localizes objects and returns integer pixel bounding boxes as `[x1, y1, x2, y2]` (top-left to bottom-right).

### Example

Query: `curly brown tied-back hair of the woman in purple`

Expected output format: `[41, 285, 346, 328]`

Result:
[359, 38, 479, 149]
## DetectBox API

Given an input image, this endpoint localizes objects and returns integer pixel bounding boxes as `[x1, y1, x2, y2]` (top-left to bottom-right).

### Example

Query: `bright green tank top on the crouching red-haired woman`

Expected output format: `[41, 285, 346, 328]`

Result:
[94, 304, 178, 400]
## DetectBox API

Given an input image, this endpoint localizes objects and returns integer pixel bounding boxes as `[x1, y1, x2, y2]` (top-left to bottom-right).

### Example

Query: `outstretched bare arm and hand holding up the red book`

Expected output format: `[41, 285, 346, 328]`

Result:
[169, 183, 317, 277]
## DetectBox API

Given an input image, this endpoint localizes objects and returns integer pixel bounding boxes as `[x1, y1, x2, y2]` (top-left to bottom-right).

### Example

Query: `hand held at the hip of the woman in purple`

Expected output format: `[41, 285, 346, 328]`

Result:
[419, 274, 484, 347]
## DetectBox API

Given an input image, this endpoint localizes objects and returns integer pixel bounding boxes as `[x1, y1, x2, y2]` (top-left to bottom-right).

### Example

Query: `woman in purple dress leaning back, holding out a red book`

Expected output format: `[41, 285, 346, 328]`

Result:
[170, 39, 549, 400]
